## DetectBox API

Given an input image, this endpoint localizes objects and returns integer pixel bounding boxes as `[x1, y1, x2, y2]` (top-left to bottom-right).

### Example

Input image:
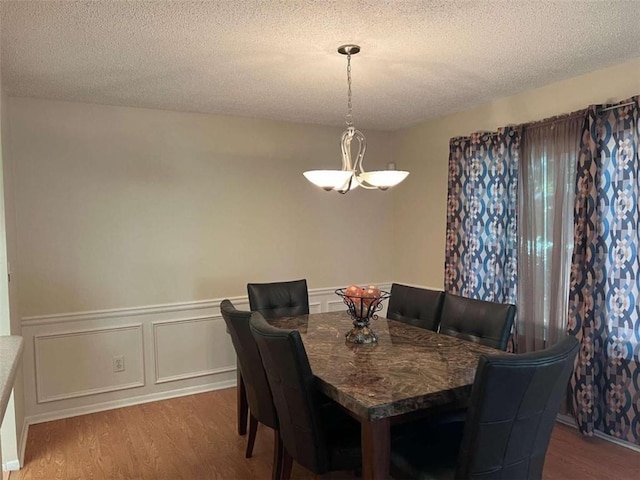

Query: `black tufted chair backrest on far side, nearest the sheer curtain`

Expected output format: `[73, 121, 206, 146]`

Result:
[440, 293, 516, 350]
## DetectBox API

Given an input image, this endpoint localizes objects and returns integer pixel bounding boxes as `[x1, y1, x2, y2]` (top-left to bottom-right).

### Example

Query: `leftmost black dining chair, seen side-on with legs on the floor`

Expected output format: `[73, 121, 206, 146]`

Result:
[220, 300, 282, 480]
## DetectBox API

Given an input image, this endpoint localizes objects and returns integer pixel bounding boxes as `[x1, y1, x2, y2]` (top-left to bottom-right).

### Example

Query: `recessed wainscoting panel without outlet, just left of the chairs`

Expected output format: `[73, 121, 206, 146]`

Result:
[153, 316, 236, 383]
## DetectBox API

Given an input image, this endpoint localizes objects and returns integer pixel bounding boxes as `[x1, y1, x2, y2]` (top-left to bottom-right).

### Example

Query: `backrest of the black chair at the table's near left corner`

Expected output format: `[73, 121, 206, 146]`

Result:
[250, 312, 329, 474]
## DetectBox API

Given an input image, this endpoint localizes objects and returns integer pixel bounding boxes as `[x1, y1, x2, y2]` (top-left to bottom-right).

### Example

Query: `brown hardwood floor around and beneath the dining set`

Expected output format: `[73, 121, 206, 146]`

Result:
[10, 388, 640, 480]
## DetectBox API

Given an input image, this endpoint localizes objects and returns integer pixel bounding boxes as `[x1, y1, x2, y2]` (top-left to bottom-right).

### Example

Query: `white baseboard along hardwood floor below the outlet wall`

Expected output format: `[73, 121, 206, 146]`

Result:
[25, 379, 236, 426]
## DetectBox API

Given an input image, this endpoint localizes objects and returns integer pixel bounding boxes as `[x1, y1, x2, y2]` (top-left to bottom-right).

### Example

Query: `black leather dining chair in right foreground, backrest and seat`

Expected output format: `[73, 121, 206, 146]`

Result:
[391, 336, 579, 480]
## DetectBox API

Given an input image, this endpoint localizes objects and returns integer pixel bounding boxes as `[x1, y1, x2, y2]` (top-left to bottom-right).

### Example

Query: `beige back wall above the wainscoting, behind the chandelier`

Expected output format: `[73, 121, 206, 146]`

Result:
[9, 98, 394, 318]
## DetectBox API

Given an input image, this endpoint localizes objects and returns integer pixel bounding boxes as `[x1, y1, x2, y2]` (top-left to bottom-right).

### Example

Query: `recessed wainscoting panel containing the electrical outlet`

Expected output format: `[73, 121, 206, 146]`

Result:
[34, 323, 144, 403]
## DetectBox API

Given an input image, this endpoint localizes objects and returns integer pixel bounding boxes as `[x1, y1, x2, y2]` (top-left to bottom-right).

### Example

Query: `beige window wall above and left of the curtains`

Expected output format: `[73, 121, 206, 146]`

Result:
[392, 59, 640, 288]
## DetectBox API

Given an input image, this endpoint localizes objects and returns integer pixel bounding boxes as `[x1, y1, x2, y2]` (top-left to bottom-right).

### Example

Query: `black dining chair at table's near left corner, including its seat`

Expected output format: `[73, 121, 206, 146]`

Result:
[250, 312, 362, 480]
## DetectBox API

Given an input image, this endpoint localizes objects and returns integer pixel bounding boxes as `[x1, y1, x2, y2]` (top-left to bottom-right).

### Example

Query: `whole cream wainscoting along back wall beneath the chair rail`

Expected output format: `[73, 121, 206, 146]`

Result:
[22, 283, 390, 425]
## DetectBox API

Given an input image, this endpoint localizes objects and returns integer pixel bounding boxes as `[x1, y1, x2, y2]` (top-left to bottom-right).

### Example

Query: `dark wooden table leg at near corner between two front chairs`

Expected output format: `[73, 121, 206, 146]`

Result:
[361, 418, 391, 480]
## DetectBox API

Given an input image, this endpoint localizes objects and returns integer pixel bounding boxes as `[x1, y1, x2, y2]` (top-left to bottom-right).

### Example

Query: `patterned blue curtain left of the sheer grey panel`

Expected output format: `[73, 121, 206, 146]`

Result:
[444, 127, 520, 304]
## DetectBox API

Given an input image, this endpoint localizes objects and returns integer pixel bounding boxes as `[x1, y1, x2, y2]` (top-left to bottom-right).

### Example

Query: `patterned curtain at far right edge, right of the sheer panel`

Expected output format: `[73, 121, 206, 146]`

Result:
[569, 97, 640, 444]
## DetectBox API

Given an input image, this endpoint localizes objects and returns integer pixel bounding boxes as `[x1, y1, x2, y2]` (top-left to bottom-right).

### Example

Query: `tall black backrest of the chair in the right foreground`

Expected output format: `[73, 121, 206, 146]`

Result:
[455, 336, 579, 479]
